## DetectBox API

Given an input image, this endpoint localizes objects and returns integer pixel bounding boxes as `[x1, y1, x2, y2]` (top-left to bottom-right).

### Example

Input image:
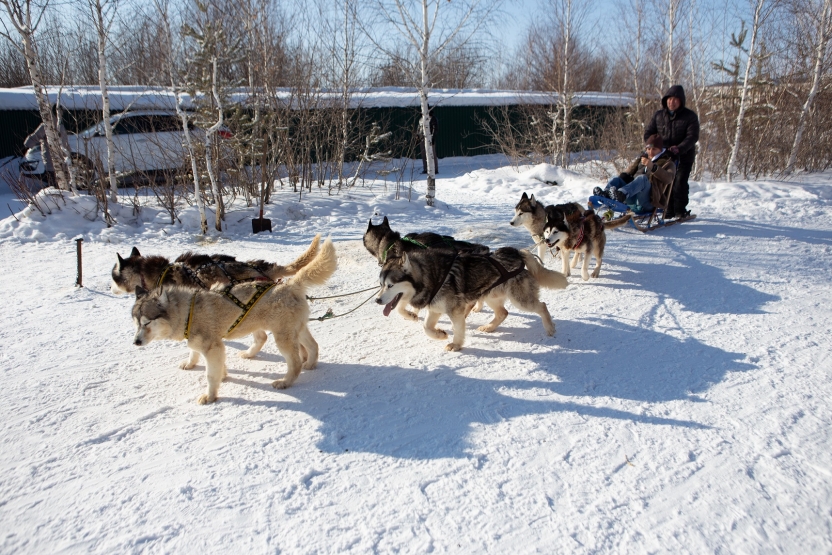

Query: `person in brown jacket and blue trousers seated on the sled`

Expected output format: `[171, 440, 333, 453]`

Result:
[592, 135, 676, 212]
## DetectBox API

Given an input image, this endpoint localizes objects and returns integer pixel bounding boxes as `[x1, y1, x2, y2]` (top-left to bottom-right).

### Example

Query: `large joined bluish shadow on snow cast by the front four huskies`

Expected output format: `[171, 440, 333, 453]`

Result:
[220, 321, 753, 459]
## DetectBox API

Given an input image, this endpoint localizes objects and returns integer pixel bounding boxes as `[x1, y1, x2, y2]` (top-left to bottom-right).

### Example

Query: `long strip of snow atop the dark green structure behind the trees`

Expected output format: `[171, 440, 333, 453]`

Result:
[0, 86, 634, 111]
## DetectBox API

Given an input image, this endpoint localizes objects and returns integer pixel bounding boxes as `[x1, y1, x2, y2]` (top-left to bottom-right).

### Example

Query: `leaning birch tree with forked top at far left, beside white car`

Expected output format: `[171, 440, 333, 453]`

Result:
[0, 0, 76, 193]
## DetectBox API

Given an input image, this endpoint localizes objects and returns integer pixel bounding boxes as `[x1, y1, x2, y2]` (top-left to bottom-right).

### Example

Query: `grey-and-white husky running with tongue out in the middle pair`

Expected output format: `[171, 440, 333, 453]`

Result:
[376, 247, 567, 351]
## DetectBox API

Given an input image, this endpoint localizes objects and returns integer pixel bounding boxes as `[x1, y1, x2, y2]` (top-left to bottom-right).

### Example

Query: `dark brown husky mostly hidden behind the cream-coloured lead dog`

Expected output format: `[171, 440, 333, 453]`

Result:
[110, 234, 321, 294]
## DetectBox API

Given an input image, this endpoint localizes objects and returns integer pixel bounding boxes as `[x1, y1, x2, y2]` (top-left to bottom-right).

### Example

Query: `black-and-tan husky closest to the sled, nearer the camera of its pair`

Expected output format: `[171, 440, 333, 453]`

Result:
[543, 210, 631, 281]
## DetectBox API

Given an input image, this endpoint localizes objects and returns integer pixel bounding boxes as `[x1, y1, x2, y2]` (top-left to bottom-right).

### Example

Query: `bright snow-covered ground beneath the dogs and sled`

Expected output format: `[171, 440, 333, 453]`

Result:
[0, 157, 832, 554]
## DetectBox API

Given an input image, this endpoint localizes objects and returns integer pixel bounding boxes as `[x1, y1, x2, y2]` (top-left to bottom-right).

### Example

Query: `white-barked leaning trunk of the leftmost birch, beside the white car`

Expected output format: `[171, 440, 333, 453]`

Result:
[0, 0, 72, 194]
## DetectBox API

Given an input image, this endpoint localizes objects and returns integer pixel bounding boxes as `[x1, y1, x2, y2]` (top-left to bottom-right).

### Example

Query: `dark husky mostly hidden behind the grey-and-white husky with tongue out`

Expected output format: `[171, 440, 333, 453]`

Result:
[364, 216, 490, 321]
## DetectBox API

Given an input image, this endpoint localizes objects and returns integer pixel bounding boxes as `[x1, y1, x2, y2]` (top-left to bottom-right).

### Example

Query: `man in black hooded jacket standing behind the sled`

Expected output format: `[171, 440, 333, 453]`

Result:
[644, 85, 699, 219]
